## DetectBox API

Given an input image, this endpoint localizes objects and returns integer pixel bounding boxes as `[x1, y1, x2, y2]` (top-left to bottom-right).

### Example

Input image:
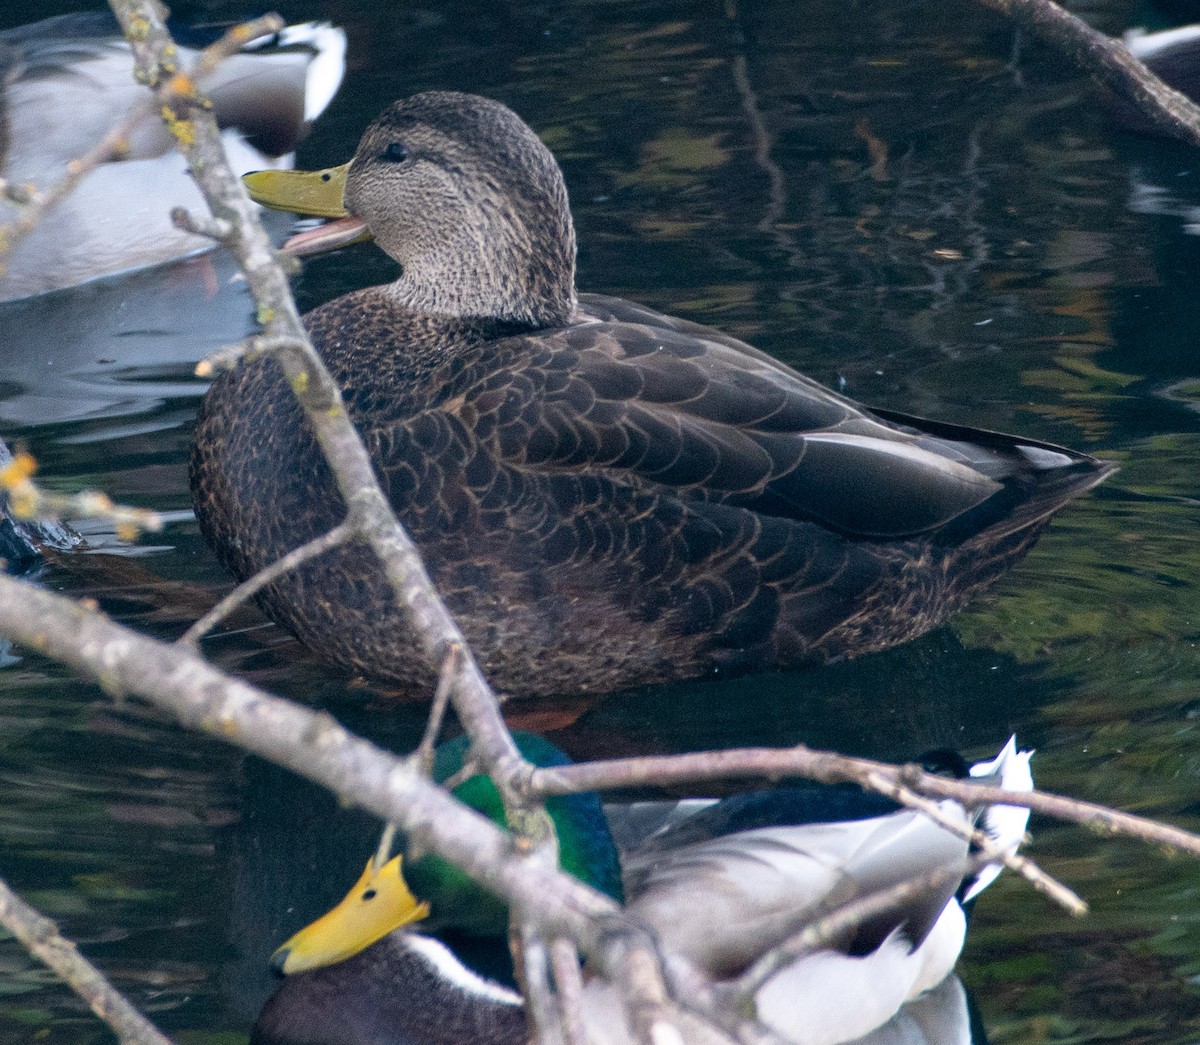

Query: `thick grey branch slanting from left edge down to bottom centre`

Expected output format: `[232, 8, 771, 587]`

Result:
[0, 576, 782, 1041]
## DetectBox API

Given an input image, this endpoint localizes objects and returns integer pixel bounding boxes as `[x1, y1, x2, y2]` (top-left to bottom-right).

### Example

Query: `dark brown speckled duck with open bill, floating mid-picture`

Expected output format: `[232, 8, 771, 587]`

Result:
[191, 91, 1111, 696]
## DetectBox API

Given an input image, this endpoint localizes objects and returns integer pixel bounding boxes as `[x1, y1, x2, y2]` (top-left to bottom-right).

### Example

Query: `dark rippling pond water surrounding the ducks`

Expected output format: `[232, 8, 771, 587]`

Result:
[0, 0, 1200, 1045]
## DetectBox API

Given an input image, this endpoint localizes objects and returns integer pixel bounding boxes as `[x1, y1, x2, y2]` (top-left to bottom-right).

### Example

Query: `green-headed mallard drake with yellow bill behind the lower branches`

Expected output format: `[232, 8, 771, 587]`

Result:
[253, 740, 1032, 1045]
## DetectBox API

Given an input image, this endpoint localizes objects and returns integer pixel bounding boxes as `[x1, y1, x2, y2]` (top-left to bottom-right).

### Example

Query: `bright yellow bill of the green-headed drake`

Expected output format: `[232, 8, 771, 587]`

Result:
[271, 857, 430, 975]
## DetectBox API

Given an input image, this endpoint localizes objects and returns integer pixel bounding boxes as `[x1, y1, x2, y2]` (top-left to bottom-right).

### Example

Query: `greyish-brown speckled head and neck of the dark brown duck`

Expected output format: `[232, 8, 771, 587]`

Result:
[346, 91, 575, 328]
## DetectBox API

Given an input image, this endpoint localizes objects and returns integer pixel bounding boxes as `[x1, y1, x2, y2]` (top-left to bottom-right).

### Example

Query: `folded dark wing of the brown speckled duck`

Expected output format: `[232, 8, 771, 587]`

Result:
[467, 298, 1099, 540]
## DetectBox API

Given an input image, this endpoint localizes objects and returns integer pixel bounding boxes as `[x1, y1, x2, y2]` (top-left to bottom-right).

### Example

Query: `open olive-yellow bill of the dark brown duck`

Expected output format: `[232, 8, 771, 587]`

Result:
[241, 163, 371, 257]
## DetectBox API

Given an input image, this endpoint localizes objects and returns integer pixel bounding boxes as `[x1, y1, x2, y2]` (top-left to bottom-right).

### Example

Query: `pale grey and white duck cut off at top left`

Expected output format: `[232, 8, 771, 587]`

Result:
[0, 12, 346, 300]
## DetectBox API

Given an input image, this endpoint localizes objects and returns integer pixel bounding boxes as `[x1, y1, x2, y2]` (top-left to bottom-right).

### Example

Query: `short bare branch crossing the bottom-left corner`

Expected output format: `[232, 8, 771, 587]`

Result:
[0, 881, 170, 1045]
